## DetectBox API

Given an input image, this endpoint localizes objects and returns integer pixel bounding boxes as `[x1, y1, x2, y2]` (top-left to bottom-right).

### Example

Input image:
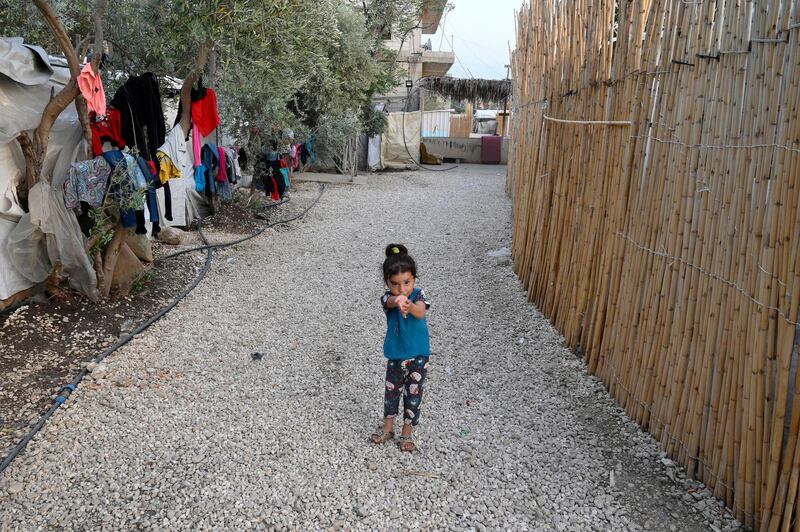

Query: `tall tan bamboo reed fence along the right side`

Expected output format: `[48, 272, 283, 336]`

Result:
[507, 0, 800, 531]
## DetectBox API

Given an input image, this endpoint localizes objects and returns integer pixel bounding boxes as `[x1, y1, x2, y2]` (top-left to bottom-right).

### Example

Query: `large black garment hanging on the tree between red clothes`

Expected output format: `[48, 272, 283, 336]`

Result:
[111, 72, 167, 169]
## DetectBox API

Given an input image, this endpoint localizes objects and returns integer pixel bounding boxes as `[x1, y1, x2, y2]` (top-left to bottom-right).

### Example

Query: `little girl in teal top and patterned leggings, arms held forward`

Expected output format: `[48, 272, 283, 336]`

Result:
[371, 244, 431, 452]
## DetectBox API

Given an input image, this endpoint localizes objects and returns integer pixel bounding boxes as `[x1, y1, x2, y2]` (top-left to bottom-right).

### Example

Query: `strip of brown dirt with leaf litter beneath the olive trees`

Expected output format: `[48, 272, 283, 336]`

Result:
[0, 189, 271, 461]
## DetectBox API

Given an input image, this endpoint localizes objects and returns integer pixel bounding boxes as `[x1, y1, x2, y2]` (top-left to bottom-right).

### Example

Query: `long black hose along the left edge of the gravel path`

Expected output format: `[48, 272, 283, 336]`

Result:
[0, 183, 325, 474]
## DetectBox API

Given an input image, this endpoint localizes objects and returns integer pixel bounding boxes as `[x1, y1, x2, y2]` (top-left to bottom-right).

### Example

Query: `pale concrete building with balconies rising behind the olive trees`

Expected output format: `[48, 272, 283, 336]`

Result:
[374, 0, 455, 111]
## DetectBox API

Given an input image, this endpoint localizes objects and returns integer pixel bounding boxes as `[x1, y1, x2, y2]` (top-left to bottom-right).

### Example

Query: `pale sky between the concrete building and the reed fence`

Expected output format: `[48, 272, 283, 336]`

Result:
[422, 0, 522, 79]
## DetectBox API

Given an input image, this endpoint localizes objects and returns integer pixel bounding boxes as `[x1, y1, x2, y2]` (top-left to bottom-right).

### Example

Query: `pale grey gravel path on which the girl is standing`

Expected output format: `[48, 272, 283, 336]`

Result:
[0, 166, 738, 530]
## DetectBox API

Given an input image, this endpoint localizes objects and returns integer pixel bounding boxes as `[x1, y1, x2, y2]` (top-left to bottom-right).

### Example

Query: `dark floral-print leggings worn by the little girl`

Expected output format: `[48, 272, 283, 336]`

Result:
[383, 357, 428, 425]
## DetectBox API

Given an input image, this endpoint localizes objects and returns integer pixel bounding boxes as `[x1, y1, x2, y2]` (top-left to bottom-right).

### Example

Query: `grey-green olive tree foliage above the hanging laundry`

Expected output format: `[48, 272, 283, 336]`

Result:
[7, 0, 432, 160]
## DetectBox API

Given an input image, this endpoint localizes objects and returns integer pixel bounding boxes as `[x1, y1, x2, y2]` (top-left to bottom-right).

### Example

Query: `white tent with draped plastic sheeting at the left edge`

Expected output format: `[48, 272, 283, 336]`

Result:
[0, 38, 96, 308]
